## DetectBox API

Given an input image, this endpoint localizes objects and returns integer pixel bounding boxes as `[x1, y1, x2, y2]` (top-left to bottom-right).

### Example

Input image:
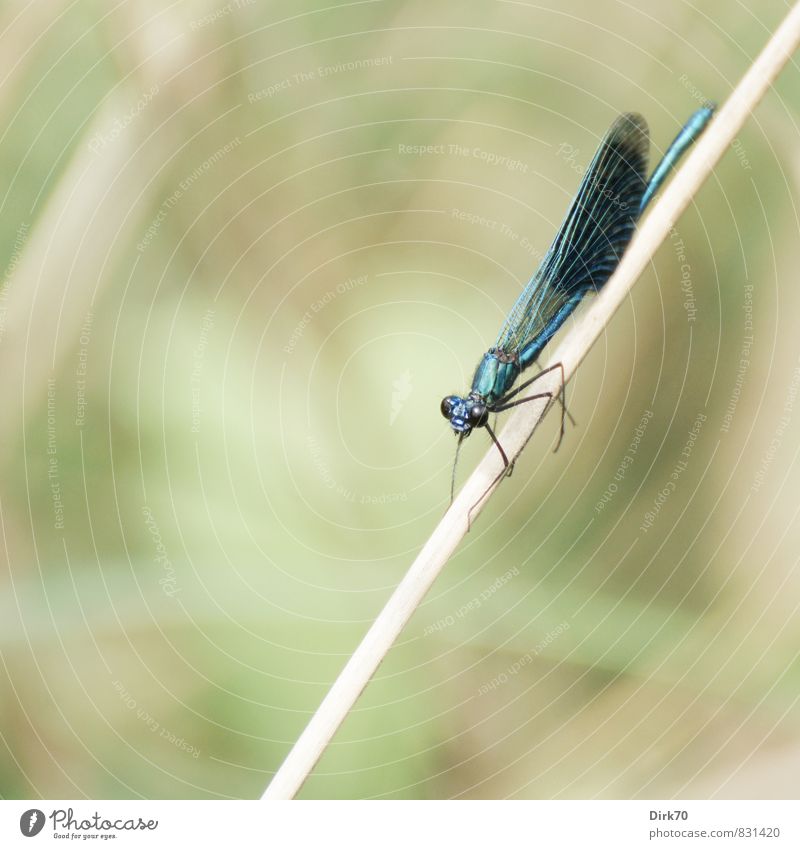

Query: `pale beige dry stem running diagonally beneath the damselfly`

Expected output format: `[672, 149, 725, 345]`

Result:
[262, 2, 800, 799]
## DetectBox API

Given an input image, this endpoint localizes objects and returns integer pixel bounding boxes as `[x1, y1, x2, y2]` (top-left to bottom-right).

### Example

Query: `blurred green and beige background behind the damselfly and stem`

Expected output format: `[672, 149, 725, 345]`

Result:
[0, 0, 800, 798]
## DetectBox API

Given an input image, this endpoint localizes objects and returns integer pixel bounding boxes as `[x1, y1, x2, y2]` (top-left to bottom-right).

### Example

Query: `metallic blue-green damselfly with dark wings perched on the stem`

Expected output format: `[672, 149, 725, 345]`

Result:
[441, 103, 714, 499]
